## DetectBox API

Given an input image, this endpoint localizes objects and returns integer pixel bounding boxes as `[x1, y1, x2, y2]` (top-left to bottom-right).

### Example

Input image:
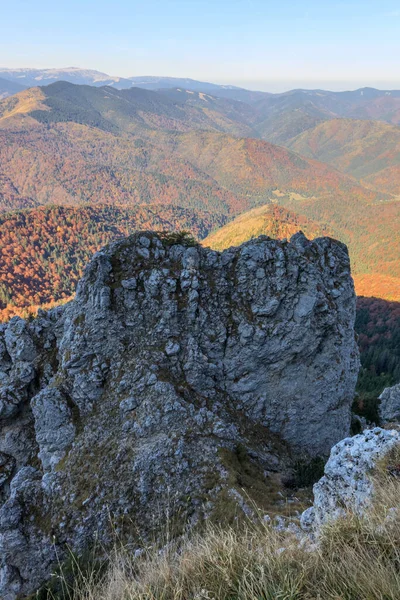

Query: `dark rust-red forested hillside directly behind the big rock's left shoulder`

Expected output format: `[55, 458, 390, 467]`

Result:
[0, 206, 224, 320]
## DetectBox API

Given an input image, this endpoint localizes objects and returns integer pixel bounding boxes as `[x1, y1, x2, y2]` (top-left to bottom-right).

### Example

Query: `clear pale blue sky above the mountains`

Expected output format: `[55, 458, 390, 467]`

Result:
[0, 0, 400, 92]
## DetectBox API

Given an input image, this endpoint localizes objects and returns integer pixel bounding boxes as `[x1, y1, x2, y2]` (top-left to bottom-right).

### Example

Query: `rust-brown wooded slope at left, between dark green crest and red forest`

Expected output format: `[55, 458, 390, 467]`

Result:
[0, 122, 246, 214]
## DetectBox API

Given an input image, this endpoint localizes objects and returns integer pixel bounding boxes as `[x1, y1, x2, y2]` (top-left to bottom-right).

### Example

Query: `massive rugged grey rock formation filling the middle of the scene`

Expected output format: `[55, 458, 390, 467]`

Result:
[0, 232, 359, 600]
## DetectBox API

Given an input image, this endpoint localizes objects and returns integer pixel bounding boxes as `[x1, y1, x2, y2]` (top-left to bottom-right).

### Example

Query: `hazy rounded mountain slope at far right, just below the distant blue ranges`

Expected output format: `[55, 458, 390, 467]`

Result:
[288, 119, 400, 195]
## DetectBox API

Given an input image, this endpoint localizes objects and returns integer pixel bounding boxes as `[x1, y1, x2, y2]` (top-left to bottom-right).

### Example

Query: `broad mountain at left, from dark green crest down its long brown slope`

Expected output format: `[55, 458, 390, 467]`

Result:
[0, 83, 381, 214]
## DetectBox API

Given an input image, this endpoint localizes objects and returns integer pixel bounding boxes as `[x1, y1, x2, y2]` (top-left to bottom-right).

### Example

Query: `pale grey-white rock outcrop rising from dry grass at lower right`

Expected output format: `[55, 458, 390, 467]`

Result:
[301, 427, 400, 533]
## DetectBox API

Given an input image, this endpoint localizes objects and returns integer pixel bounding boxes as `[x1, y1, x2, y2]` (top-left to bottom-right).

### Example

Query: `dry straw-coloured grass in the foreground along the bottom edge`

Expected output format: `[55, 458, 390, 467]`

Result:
[43, 454, 400, 600]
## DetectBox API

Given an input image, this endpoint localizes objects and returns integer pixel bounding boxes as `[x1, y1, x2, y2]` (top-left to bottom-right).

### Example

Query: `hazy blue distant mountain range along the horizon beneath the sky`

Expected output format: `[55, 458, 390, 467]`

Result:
[0, 67, 400, 127]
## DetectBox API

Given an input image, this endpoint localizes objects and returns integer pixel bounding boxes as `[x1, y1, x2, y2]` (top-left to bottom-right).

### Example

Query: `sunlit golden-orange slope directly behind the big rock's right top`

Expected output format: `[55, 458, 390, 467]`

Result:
[203, 198, 400, 300]
